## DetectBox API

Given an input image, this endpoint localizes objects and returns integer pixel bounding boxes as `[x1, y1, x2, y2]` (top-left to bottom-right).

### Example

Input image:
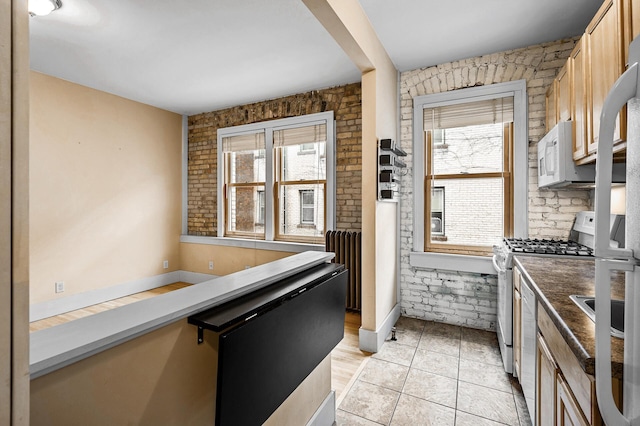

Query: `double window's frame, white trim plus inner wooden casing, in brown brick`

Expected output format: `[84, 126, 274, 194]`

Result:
[217, 111, 336, 244]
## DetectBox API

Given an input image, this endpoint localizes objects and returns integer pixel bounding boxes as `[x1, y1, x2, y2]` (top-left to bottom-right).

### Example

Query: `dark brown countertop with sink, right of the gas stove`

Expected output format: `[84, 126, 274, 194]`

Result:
[514, 256, 624, 378]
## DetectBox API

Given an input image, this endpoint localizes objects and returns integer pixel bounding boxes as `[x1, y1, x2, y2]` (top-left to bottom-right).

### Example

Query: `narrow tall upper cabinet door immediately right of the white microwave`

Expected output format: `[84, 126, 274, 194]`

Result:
[569, 36, 589, 160]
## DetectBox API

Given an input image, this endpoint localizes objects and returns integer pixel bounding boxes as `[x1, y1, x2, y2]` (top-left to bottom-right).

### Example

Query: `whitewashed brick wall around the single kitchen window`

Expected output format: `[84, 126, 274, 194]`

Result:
[400, 39, 590, 330]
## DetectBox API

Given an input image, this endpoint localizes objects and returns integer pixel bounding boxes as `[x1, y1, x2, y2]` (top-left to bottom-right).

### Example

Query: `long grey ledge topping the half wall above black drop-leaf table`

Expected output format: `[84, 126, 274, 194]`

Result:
[29, 251, 334, 379]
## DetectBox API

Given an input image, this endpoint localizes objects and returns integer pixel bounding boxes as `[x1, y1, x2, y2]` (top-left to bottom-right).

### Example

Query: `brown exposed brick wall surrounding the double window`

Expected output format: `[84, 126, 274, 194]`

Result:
[188, 83, 362, 236]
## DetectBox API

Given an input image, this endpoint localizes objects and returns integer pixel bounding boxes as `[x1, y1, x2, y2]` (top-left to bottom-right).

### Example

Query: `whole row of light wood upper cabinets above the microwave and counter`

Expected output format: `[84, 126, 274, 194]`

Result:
[546, 0, 640, 164]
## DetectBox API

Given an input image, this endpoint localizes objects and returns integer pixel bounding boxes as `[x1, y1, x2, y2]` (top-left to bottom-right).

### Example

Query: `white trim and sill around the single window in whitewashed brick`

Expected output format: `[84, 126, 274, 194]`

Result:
[409, 80, 529, 274]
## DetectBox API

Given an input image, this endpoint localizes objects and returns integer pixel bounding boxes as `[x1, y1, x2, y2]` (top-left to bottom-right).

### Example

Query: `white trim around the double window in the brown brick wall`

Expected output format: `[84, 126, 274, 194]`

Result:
[215, 111, 336, 246]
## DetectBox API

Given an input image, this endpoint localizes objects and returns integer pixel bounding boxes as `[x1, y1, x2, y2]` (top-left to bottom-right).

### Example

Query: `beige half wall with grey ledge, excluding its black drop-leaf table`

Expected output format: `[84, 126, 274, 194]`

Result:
[31, 252, 344, 425]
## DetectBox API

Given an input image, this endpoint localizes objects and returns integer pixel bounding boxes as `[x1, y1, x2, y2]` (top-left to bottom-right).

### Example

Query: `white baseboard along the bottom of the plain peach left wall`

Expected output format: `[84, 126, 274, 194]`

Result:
[29, 271, 216, 322]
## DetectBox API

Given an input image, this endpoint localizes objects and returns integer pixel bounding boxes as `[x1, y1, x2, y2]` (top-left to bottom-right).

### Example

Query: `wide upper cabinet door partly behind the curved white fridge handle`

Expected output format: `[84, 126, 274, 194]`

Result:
[587, 0, 625, 154]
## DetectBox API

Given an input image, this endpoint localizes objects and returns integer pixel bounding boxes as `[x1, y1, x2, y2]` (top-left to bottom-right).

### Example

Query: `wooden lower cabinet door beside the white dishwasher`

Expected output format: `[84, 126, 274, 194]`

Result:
[536, 334, 558, 426]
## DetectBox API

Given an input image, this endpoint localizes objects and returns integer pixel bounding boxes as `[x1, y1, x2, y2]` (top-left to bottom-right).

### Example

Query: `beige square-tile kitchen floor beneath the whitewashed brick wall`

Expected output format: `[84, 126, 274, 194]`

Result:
[336, 317, 531, 426]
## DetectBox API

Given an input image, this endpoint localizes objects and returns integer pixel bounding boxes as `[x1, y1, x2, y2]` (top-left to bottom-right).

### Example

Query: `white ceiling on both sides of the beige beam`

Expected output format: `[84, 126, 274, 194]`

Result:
[30, 0, 602, 115]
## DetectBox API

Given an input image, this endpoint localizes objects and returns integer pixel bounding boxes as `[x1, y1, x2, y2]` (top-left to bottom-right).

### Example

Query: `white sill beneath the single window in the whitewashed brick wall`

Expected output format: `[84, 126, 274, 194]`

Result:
[409, 251, 496, 275]
